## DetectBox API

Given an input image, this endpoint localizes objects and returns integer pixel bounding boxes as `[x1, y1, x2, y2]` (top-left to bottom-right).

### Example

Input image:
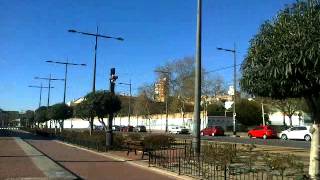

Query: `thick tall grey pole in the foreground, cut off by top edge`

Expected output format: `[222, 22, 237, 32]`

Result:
[192, 0, 202, 156]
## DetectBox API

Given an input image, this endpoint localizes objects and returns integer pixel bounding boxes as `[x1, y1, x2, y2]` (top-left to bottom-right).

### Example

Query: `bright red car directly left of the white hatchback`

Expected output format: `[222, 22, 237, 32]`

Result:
[248, 126, 277, 139]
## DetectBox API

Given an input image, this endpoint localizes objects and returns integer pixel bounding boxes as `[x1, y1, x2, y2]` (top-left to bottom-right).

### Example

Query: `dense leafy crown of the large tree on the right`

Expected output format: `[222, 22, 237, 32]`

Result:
[240, 0, 320, 121]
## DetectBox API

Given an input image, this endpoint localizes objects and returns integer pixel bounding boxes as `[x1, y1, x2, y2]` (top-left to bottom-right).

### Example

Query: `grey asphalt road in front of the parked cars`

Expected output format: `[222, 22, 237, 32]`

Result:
[175, 135, 310, 149]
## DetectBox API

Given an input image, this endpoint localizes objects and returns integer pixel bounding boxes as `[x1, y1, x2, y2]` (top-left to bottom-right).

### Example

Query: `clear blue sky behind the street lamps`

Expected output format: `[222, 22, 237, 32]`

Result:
[0, 0, 295, 111]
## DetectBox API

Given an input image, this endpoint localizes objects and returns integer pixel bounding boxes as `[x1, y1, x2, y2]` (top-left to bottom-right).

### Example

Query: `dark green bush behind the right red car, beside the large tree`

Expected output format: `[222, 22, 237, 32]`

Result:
[236, 99, 262, 126]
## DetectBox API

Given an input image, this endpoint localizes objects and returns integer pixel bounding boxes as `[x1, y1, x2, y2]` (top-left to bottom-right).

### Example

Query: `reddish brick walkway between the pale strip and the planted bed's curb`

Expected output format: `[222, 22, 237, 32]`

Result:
[29, 140, 178, 180]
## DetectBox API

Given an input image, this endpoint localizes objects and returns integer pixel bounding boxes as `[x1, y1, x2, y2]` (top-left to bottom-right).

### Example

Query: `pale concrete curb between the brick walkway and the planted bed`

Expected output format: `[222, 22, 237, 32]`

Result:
[54, 140, 195, 180]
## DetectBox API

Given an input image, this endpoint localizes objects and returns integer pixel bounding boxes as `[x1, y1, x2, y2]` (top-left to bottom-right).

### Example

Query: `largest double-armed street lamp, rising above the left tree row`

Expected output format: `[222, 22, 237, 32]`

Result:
[68, 26, 124, 92]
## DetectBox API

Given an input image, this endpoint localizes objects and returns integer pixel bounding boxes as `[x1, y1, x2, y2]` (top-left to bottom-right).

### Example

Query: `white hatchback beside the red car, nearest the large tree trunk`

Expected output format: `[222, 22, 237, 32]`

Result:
[279, 126, 312, 141]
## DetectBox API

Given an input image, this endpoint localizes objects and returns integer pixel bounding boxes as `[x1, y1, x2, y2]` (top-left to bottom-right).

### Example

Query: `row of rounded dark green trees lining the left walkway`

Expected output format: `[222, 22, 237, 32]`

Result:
[22, 91, 121, 134]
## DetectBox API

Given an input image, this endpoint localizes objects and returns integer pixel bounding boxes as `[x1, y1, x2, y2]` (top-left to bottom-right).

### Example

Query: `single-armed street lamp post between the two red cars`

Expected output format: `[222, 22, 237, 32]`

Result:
[217, 44, 237, 136]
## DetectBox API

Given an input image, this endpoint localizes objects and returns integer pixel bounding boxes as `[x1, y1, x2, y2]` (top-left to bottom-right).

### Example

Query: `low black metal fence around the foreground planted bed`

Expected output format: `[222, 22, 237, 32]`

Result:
[149, 141, 308, 180]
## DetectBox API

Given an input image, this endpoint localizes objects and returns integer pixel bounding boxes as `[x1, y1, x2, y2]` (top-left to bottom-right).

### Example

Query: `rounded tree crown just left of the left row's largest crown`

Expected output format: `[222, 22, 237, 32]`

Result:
[48, 103, 73, 120]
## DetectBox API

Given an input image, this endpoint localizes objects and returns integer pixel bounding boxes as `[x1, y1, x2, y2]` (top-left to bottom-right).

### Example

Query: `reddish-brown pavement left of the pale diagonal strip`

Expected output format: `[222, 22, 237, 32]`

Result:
[0, 138, 45, 179]
